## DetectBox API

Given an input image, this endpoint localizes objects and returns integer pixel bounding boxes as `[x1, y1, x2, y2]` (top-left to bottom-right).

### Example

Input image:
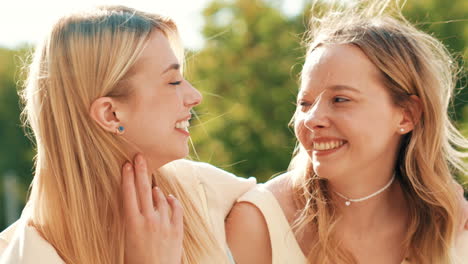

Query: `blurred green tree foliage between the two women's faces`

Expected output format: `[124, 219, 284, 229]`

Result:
[188, 0, 305, 181]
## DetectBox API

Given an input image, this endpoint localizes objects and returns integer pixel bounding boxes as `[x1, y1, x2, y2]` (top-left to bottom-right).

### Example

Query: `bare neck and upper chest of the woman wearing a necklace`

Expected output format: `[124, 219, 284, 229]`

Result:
[335, 180, 409, 263]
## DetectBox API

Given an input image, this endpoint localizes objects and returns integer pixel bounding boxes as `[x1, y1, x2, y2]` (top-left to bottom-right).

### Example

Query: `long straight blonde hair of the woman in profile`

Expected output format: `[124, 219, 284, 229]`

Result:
[22, 6, 224, 264]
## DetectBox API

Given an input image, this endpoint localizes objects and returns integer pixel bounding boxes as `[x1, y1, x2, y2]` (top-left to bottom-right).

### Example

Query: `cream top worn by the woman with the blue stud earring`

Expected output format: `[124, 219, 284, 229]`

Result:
[0, 160, 256, 264]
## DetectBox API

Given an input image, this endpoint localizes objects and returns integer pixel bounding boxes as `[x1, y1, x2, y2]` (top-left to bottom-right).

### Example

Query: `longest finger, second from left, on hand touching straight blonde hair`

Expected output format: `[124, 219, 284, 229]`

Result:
[135, 154, 154, 215]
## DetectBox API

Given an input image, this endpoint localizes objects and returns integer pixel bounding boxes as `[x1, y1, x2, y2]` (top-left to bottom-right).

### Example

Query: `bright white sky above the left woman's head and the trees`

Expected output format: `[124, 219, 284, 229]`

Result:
[0, 0, 304, 49]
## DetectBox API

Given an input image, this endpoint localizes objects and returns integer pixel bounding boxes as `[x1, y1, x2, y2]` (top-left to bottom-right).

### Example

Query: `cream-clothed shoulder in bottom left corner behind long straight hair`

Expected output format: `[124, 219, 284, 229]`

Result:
[0, 219, 65, 264]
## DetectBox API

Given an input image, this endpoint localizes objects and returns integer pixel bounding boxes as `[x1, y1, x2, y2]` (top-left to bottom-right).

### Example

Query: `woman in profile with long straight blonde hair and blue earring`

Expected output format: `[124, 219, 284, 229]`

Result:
[0, 6, 254, 264]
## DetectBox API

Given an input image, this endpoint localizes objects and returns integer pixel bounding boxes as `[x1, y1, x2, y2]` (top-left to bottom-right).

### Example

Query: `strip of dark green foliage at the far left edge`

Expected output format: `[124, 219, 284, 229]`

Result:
[0, 47, 34, 229]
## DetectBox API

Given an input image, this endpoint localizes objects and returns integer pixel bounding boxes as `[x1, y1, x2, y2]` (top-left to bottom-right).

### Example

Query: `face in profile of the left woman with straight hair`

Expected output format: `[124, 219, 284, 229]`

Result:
[118, 30, 202, 168]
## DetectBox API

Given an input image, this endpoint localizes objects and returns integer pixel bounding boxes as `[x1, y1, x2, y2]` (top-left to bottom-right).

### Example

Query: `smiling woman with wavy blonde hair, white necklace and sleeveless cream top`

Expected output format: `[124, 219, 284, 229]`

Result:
[226, 1, 468, 264]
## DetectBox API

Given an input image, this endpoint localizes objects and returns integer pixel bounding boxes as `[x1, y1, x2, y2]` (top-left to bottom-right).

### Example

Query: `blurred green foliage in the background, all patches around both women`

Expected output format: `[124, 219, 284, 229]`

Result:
[0, 0, 468, 230]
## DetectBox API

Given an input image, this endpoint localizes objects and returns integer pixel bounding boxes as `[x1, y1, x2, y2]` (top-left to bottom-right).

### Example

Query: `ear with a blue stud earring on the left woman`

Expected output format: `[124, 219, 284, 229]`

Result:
[89, 97, 121, 133]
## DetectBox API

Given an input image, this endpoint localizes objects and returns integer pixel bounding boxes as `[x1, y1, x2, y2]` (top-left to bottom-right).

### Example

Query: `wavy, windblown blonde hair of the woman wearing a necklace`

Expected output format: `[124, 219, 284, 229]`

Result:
[289, 0, 468, 264]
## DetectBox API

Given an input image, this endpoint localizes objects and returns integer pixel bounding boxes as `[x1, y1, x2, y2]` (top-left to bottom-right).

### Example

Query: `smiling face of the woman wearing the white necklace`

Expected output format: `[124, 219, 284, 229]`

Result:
[295, 45, 403, 179]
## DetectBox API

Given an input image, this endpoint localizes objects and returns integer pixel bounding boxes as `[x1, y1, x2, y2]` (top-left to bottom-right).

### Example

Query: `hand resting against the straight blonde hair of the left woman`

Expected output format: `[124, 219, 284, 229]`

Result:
[122, 154, 183, 264]
